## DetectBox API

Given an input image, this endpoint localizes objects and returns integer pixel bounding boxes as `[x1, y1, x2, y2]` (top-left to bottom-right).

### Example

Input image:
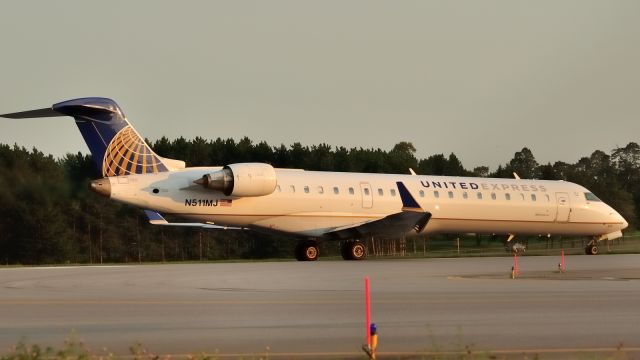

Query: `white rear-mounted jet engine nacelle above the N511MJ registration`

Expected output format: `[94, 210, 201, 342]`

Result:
[194, 163, 276, 196]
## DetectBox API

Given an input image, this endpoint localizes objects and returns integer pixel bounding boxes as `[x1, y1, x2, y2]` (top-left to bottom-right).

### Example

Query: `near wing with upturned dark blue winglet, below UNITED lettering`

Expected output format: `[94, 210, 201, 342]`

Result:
[324, 181, 431, 240]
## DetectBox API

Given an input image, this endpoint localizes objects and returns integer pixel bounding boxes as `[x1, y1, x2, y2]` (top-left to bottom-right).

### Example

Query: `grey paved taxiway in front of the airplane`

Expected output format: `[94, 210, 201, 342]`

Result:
[0, 255, 640, 356]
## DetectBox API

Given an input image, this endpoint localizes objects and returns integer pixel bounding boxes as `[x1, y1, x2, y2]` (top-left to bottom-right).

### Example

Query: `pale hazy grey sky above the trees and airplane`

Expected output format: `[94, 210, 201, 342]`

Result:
[0, 0, 640, 169]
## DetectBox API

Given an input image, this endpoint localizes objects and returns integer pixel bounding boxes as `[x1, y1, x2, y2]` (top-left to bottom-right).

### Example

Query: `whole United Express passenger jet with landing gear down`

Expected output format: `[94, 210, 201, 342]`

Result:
[0, 97, 628, 261]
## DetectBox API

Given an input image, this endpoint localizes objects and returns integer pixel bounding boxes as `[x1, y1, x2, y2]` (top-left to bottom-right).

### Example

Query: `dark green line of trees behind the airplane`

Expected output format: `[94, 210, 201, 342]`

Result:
[0, 137, 640, 264]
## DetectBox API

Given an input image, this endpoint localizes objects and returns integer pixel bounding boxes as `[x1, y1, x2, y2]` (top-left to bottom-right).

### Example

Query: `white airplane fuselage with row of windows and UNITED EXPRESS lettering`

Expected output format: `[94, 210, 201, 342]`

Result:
[102, 167, 627, 238]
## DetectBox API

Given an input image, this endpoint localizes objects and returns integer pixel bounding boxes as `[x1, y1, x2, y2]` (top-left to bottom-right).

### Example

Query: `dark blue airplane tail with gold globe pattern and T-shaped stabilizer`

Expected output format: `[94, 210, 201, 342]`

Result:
[0, 97, 184, 177]
